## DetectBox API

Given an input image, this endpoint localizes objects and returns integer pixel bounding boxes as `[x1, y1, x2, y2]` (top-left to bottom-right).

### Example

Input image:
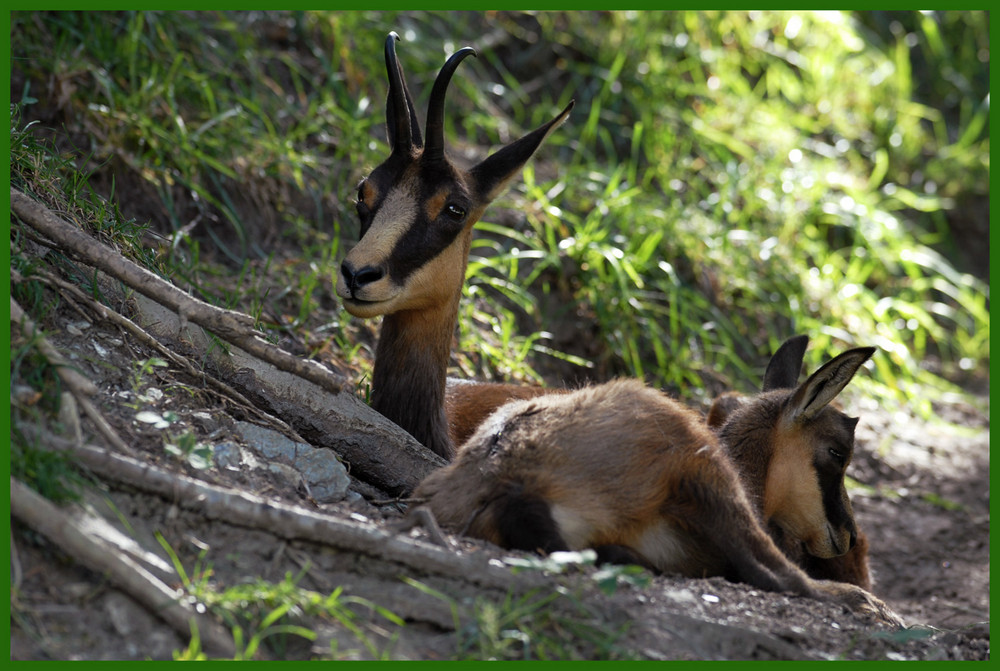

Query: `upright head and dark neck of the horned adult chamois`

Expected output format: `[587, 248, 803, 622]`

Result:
[336, 33, 573, 459]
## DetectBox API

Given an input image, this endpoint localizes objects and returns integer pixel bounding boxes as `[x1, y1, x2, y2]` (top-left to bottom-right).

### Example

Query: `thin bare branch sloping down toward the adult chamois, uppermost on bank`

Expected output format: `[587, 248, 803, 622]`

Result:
[10, 187, 343, 394]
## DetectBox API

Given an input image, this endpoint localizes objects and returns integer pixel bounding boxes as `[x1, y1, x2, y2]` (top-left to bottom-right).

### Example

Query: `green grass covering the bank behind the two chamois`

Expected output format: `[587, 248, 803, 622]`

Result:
[12, 12, 989, 410]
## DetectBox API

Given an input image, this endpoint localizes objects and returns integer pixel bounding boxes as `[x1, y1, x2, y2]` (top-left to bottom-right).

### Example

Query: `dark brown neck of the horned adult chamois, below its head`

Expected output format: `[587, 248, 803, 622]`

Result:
[372, 297, 458, 460]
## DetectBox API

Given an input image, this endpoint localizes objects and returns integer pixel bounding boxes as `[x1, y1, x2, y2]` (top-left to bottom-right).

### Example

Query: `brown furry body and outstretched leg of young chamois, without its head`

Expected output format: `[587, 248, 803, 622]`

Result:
[413, 372, 901, 624]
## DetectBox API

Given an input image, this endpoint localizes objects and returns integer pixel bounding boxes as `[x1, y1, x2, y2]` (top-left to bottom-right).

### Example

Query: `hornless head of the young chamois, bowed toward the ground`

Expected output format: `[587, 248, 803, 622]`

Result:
[710, 336, 875, 558]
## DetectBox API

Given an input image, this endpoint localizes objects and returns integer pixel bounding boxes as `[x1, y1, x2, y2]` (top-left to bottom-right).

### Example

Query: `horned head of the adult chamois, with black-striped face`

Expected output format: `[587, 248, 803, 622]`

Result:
[337, 33, 573, 328]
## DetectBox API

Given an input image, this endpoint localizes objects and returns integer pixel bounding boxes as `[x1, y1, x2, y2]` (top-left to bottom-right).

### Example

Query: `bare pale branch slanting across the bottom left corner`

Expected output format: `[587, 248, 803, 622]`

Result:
[10, 477, 236, 658]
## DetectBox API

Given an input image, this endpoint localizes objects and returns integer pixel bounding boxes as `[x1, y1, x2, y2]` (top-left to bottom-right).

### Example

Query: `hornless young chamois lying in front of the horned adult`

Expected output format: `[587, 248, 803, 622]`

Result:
[413, 343, 902, 625]
